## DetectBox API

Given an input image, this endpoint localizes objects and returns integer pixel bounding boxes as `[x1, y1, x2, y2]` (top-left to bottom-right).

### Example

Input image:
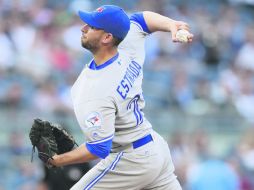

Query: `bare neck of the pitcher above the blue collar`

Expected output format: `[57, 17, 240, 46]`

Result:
[93, 48, 117, 66]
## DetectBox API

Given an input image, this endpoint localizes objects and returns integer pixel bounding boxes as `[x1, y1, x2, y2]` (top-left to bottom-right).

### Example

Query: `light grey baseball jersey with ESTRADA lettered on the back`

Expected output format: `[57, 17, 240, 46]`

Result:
[71, 14, 151, 157]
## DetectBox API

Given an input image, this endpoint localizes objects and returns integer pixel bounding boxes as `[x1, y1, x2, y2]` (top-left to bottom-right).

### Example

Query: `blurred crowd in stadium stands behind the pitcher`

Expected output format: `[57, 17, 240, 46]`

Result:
[0, 0, 254, 190]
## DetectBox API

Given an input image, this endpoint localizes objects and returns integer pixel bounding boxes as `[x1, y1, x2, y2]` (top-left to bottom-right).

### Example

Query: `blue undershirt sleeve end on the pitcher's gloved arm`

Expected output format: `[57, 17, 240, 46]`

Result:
[86, 136, 113, 159]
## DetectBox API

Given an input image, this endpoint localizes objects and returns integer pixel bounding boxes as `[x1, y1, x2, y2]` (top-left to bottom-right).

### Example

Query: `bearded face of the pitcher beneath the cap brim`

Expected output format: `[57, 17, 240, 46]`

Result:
[81, 24, 105, 53]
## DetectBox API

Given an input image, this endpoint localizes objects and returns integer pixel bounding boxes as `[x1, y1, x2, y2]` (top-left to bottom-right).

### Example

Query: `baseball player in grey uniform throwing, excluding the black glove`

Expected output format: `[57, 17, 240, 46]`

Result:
[41, 5, 193, 190]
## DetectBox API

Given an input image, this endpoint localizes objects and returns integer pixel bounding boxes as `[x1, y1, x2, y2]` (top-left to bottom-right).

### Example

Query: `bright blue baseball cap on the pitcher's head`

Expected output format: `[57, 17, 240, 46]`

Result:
[78, 5, 130, 39]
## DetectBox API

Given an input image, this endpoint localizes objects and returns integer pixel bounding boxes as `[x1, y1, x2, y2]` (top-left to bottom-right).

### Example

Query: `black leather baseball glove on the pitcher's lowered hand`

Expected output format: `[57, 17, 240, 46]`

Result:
[29, 119, 77, 168]
